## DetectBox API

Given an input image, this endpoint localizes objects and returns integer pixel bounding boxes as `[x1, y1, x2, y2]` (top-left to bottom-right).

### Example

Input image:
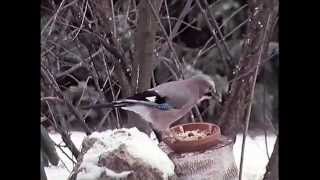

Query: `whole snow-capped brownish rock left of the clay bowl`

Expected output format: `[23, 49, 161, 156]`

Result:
[69, 128, 176, 180]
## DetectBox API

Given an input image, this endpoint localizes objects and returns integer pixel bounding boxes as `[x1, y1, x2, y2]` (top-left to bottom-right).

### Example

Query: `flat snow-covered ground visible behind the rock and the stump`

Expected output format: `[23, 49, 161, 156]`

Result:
[45, 131, 276, 180]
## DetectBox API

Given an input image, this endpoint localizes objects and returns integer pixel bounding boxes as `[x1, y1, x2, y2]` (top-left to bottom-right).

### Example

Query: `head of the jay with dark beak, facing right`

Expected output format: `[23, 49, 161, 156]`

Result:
[192, 74, 221, 103]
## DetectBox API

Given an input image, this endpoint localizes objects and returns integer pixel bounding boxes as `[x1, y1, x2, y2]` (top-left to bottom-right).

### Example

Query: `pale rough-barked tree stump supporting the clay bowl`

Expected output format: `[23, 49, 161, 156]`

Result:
[160, 137, 238, 180]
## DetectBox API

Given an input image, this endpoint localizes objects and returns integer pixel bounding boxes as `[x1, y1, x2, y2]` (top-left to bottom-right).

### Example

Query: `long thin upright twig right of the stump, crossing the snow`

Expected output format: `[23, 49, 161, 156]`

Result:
[239, 15, 271, 180]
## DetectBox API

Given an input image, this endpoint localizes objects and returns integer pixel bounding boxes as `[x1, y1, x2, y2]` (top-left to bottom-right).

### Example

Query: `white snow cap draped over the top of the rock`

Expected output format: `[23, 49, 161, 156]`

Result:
[82, 128, 174, 179]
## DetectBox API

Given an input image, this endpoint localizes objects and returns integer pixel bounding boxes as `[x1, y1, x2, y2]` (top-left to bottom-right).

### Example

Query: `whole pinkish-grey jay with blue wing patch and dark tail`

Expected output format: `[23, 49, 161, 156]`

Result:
[82, 74, 221, 139]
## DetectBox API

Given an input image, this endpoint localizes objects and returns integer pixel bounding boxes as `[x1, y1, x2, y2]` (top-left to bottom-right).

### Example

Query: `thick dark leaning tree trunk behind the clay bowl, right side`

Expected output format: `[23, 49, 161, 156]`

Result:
[219, 0, 278, 138]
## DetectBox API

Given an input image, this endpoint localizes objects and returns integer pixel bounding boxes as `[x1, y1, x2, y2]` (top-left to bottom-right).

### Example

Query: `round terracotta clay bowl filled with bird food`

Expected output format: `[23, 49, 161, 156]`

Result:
[164, 123, 221, 153]
